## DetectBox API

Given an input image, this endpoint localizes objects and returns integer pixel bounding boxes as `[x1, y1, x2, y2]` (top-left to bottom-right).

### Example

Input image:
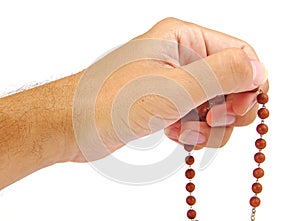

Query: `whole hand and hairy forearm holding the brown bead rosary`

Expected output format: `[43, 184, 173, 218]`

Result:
[0, 18, 268, 189]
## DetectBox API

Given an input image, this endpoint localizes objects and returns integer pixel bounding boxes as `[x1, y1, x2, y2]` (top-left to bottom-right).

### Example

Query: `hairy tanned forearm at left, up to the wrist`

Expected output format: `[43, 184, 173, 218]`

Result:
[0, 73, 81, 189]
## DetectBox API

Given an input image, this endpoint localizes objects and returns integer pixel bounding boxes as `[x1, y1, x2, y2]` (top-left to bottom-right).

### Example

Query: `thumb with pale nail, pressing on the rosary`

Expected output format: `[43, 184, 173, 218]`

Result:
[176, 48, 267, 105]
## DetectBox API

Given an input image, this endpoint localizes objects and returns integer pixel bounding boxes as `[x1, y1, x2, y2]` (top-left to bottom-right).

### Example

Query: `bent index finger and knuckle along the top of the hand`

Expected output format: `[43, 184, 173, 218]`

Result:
[138, 18, 258, 60]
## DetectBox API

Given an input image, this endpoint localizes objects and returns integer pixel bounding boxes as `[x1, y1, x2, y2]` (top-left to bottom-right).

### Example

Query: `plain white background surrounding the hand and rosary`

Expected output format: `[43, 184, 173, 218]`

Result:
[0, 0, 300, 221]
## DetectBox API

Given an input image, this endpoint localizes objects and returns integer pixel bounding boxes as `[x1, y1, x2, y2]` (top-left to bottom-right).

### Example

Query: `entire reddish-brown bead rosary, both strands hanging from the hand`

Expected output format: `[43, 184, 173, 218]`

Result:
[184, 90, 269, 221]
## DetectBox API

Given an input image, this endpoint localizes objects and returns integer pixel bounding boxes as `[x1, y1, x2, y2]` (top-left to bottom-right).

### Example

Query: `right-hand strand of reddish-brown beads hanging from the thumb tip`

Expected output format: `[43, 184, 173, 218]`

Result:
[250, 90, 270, 221]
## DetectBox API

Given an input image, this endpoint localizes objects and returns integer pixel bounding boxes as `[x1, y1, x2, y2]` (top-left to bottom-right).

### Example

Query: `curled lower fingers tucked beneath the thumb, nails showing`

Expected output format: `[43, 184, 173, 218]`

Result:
[165, 89, 264, 149]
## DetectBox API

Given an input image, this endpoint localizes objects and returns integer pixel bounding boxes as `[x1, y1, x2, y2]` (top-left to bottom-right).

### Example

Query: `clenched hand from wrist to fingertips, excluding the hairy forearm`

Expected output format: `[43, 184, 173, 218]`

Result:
[73, 18, 268, 161]
